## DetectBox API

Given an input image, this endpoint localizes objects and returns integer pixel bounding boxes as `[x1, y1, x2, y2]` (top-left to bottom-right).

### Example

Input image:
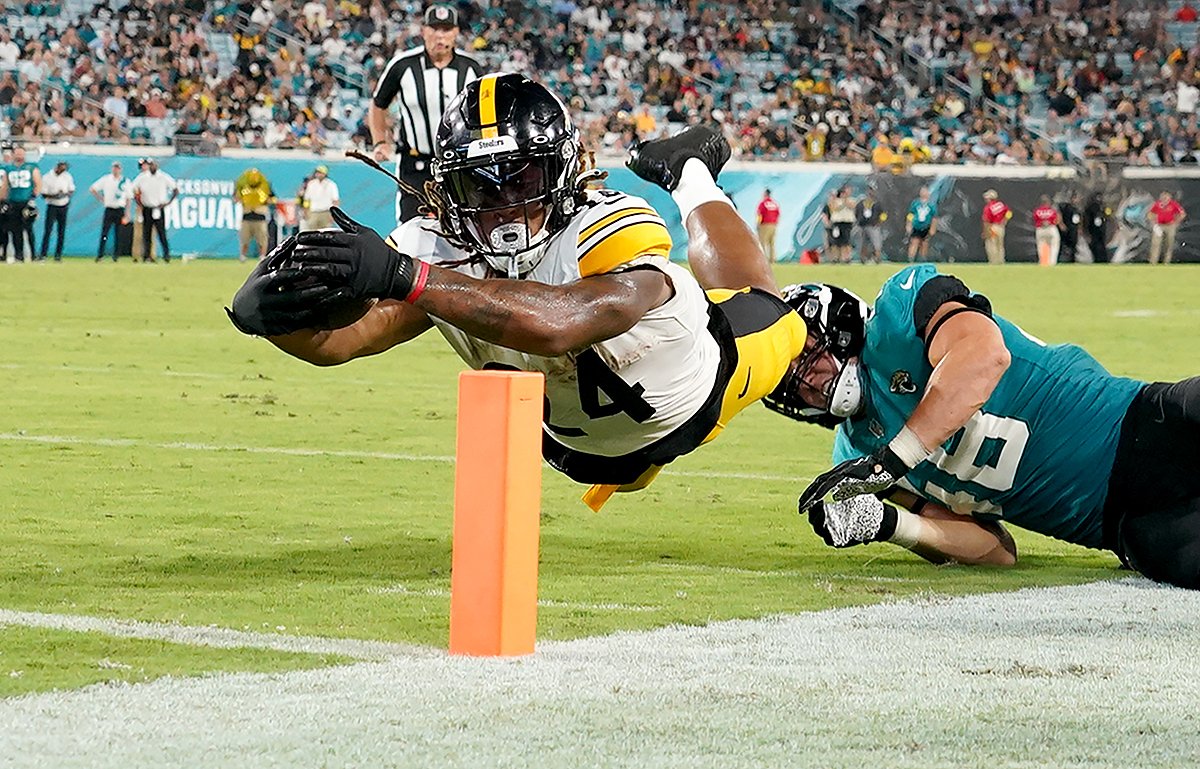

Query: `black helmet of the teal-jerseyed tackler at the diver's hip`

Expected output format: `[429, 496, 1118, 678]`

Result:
[762, 283, 871, 428]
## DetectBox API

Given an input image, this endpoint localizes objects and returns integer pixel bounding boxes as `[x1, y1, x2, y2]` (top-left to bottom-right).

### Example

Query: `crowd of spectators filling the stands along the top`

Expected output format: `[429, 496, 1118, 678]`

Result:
[0, 0, 1200, 168]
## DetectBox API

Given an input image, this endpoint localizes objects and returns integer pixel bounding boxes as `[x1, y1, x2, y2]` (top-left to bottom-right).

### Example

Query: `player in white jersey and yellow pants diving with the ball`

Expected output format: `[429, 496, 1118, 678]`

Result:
[229, 73, 805, 509]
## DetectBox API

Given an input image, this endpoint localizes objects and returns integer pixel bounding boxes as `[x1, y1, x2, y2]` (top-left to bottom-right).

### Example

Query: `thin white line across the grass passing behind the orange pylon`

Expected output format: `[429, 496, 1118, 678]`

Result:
[0, 432, 809, 488]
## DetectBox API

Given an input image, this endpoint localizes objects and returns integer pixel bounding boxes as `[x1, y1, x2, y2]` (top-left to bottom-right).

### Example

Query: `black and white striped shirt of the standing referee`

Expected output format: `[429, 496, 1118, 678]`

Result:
[372, 47, 484, 156]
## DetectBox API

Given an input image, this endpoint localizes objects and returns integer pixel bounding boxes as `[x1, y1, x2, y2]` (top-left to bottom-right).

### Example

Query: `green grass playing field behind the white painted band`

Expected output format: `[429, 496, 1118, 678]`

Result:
[0, 260, 1200, 696]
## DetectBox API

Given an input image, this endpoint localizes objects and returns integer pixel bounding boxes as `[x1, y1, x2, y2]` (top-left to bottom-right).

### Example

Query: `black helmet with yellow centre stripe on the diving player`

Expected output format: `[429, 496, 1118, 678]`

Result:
[432, 73, 581, 277]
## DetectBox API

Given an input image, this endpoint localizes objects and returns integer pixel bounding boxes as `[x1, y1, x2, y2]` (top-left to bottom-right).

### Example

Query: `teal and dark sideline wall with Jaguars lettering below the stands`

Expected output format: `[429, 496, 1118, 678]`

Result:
[38, 152, 1200, 262]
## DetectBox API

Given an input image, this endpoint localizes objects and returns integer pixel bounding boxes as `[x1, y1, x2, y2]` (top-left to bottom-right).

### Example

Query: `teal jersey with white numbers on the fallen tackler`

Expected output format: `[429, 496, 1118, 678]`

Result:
[834, 264, 1145, 547]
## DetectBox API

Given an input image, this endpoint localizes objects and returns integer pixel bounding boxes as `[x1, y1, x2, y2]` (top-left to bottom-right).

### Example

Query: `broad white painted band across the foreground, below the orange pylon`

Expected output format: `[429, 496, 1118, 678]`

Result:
[0, 578, 1200, 769]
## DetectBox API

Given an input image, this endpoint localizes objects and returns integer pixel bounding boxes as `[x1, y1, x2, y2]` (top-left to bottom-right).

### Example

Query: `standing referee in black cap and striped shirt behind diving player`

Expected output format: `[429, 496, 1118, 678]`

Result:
[367, 5, 482, 224]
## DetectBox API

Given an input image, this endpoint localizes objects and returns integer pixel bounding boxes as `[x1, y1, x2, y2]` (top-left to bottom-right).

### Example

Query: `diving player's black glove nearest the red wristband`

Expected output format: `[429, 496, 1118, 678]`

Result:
[294, 208, 420, 300]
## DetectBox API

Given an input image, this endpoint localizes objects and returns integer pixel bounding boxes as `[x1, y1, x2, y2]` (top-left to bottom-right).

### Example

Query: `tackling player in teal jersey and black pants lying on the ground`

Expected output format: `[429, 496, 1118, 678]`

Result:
[643, 130, 1200, 588]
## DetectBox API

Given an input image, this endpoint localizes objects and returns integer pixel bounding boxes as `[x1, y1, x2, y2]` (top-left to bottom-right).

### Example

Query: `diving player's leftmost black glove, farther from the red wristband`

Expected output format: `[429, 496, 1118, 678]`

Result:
[226, 236, 349, 336]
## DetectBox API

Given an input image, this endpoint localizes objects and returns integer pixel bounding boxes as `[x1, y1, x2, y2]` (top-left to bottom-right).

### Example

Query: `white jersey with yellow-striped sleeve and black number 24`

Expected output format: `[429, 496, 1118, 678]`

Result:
[390, 190, 721, 457]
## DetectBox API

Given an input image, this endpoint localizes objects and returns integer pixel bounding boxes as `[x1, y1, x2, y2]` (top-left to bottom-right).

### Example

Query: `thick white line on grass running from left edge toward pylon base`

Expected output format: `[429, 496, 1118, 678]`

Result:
[0, 608, 432, 662]
